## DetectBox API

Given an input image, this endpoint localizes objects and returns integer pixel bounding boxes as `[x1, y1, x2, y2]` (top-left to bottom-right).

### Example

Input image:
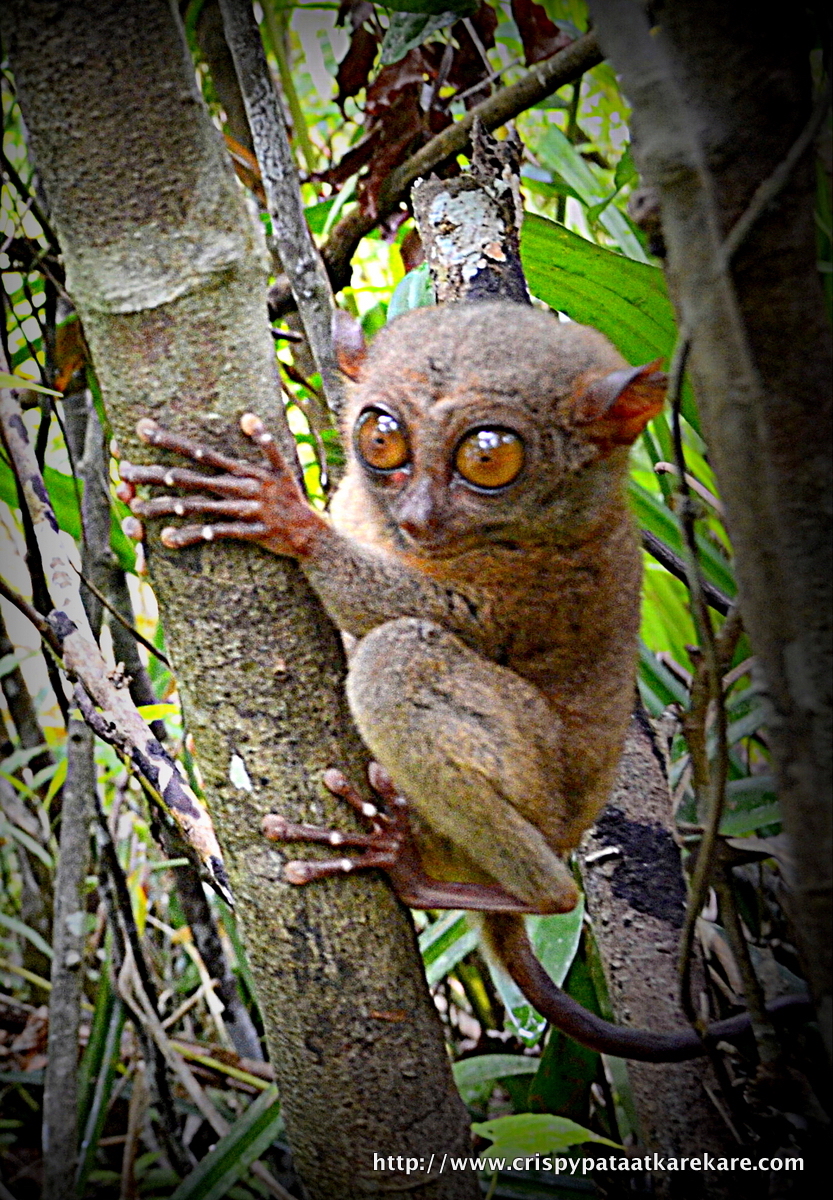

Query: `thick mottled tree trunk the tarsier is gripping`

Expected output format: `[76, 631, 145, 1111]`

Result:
[4, 0, 475, 1200]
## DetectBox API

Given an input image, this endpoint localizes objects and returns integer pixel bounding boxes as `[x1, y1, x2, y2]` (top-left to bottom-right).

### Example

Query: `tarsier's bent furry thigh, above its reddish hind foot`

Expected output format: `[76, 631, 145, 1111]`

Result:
[347, 618, 571, 902]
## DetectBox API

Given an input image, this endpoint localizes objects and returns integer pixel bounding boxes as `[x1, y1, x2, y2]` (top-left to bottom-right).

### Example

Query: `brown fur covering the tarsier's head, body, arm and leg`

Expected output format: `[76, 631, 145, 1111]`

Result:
[307, 302, 658, 908]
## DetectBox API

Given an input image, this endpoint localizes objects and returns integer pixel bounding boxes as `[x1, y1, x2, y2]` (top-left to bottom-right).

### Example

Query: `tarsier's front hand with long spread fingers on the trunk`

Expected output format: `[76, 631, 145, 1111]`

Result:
[119, 413, 326, 558]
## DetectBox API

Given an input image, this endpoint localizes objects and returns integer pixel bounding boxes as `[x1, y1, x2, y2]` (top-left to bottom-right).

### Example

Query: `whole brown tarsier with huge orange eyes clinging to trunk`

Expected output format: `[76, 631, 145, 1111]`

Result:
[121, 301, 787, 1060]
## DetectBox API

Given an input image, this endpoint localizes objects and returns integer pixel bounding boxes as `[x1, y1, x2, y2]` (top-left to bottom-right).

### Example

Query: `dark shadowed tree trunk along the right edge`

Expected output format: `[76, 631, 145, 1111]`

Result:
[591, 0, 833, 1048]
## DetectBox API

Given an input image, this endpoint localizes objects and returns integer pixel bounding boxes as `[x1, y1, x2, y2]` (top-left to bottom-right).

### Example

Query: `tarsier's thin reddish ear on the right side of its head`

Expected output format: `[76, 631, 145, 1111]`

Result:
[573, 359, 669, 446]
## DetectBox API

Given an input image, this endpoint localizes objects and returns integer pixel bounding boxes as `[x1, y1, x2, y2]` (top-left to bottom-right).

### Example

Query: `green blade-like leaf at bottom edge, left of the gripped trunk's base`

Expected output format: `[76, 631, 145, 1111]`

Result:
[170, 1086, 283, 1200]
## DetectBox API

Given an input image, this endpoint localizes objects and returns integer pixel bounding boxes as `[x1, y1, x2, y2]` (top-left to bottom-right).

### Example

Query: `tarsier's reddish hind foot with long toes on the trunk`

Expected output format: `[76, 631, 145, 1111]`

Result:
[267, 762, 542, 913]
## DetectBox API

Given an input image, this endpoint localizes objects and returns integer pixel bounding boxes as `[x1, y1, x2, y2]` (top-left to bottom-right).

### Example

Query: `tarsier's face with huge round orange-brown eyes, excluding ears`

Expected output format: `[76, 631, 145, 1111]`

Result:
[349, 304, 648, 557]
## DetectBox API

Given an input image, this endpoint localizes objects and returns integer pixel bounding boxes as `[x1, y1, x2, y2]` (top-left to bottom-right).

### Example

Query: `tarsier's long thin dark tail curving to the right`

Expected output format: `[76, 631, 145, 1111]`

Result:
[481, 913, 813, 1062]
